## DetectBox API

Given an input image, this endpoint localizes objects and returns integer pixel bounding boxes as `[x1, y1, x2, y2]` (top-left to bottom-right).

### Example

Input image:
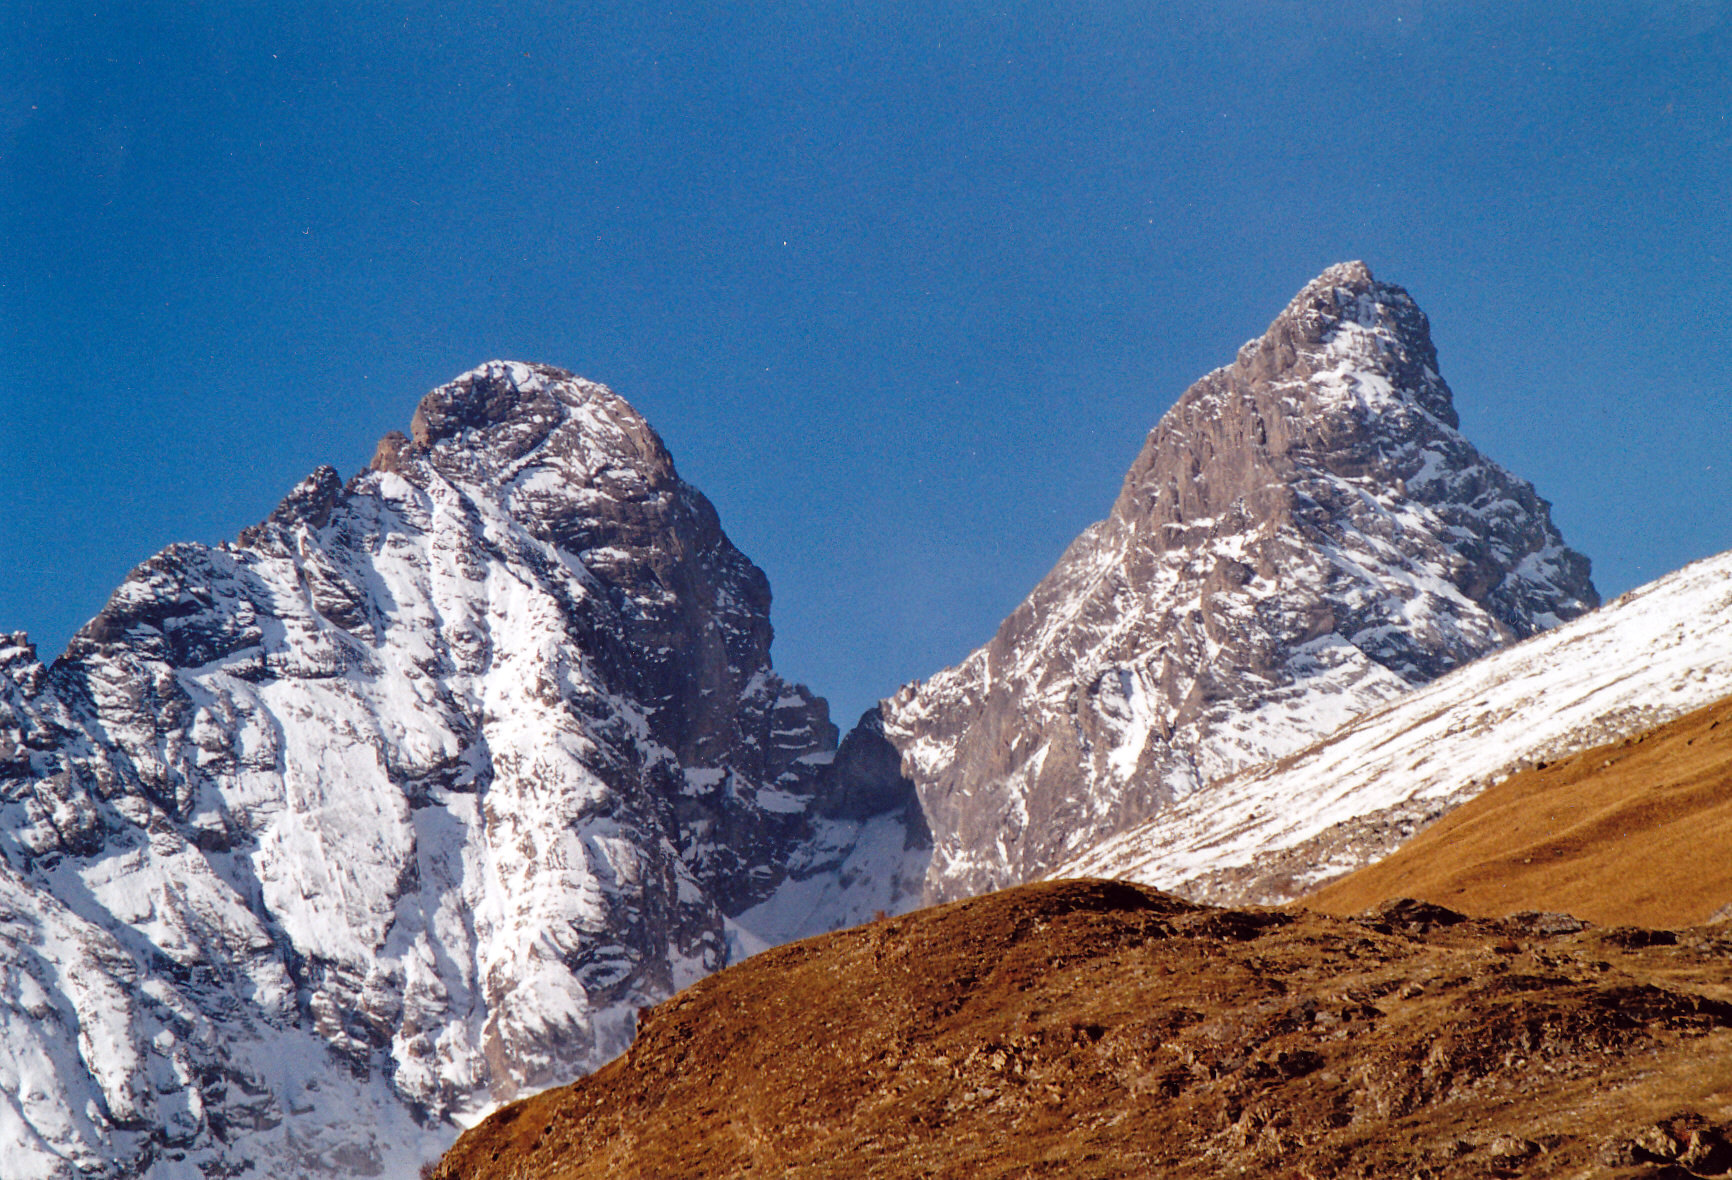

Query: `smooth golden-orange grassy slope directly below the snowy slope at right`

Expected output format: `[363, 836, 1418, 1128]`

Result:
[1299, 700, 1732, 925]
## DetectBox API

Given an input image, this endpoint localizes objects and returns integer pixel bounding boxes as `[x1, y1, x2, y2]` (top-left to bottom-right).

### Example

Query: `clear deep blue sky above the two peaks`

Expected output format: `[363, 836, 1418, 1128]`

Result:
[0, 0, 1732, 723]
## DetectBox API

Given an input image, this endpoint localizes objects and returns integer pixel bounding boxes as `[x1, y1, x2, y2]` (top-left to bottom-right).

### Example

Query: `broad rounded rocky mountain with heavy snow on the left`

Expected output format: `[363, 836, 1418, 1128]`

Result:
[0, 362, 930, 1180]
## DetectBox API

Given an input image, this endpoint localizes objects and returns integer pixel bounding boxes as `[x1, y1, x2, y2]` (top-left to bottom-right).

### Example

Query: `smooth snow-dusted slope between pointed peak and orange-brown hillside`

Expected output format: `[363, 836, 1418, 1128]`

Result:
[1053, 553, 1732, 903]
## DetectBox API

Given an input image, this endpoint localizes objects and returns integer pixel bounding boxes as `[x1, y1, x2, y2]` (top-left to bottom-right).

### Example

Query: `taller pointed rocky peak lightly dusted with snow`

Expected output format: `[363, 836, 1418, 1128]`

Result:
[883, 263, 1599, 899]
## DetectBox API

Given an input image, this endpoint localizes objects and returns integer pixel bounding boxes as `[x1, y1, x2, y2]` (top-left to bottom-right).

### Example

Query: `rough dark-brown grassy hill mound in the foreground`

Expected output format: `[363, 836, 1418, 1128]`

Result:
[435, 882, 1732, 1180]
